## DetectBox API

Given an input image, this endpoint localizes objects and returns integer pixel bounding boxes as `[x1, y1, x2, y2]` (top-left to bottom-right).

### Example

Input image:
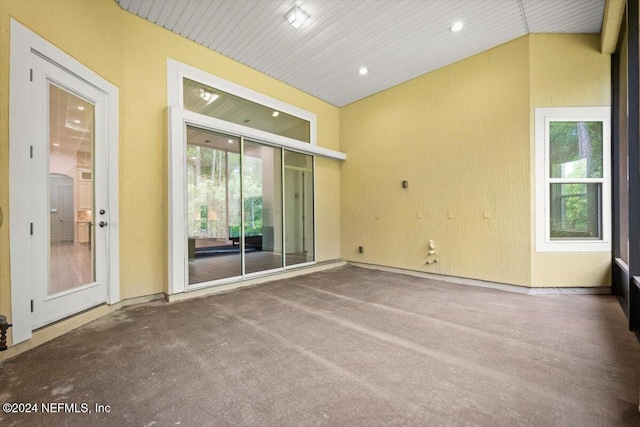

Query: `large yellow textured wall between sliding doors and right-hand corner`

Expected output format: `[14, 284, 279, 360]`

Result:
[340, 37, 531, 285]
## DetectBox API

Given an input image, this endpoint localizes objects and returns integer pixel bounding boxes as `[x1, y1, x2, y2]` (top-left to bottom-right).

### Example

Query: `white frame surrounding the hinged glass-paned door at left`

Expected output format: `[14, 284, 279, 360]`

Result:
[9, 19, 120, 345]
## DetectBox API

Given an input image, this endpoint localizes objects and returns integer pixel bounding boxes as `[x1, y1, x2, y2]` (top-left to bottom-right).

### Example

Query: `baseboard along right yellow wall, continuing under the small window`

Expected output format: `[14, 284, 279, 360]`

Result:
[348, 261, 611, 295]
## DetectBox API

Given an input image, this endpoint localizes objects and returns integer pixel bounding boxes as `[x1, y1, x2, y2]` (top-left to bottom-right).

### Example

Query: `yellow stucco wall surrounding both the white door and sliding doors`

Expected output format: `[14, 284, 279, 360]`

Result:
[0, 0, 340, 320]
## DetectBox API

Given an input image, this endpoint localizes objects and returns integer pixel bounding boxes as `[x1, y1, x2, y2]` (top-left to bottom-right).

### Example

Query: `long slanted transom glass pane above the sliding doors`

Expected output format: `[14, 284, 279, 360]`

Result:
[183, 78, 311, 142]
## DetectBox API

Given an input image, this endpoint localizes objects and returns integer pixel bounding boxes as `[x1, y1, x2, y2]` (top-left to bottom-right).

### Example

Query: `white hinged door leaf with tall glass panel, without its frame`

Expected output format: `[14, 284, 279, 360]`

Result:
[24, 54, 109, 329]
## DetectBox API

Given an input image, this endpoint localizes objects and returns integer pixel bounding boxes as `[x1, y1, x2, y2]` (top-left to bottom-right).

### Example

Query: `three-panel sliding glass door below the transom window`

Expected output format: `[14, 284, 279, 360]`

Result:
[185, 125, 315, 286]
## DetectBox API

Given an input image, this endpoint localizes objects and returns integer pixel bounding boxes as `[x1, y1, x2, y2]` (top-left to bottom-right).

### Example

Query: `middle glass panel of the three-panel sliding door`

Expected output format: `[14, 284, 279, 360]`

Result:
[242, 141, 282, 274]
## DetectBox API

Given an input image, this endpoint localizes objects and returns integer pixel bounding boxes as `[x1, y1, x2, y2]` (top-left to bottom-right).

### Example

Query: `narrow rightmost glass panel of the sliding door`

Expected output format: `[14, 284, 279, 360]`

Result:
[284, 150, 315, 265]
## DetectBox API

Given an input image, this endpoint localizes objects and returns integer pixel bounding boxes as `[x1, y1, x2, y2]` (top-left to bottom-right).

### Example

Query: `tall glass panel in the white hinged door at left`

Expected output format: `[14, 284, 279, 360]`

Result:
[48, 84, 95, 295]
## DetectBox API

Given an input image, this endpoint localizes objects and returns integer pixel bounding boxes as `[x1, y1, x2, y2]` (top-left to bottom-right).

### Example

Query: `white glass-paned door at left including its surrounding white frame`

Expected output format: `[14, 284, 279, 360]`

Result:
[9, 19, 120, 345]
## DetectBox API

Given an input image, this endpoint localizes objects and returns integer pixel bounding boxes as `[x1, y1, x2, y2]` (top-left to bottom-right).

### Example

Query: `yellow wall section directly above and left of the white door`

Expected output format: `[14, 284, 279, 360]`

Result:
[0, 0, 122, 342]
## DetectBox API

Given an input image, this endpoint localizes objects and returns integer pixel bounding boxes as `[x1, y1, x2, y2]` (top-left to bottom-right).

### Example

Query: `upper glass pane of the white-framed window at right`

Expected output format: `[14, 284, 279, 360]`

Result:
[549, 121, 603, 178]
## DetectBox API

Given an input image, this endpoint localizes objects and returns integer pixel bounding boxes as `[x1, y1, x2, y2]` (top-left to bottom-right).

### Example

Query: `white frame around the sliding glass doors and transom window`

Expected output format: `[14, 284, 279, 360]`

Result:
[167, 58, 347, 294]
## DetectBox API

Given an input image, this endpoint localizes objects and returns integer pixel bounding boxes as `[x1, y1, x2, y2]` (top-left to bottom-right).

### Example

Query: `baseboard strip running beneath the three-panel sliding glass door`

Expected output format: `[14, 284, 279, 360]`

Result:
[166, 259, 347, 302]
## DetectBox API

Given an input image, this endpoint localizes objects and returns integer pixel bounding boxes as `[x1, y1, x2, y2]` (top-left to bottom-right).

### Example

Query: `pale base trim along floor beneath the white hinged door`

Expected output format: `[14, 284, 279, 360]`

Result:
[0, 293, 165, 362]
